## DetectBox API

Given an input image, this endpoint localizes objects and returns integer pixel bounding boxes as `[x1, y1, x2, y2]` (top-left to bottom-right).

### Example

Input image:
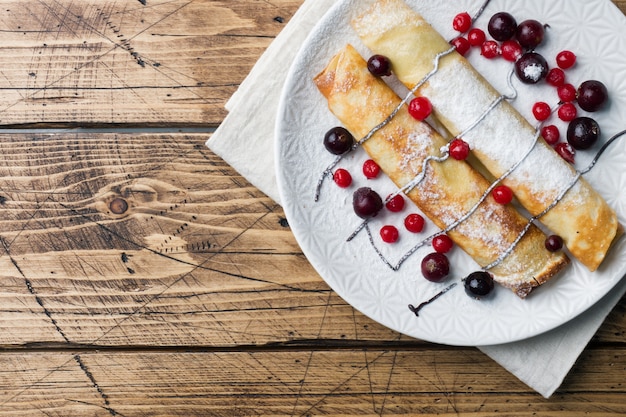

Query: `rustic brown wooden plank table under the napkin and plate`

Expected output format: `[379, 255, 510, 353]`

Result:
[0, 0, 626, 416]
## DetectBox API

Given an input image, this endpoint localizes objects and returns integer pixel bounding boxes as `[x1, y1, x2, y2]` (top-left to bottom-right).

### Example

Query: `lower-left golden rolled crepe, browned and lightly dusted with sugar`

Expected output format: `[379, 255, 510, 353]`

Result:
[315, 45, 568, 298]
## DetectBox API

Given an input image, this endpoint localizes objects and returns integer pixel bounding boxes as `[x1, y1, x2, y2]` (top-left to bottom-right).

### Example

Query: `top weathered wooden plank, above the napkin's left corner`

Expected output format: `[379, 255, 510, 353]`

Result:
[0, 0, 301, 126]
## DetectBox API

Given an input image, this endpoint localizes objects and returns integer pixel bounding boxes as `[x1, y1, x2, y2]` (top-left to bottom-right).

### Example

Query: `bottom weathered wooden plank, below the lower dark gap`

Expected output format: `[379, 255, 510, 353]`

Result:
[0, 348, 626, 417]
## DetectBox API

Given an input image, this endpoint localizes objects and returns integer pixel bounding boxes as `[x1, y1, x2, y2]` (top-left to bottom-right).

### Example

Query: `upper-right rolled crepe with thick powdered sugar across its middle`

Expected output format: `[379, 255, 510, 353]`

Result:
[352, 0, 622, 271]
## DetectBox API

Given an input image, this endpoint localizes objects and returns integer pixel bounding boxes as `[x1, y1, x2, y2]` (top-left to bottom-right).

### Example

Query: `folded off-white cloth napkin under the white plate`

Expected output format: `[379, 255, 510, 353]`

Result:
[207, 0, 626, 398]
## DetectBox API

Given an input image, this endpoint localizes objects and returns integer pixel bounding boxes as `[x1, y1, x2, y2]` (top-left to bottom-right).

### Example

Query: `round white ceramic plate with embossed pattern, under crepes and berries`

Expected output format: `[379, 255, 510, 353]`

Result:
[276, 0, 626, 345]
